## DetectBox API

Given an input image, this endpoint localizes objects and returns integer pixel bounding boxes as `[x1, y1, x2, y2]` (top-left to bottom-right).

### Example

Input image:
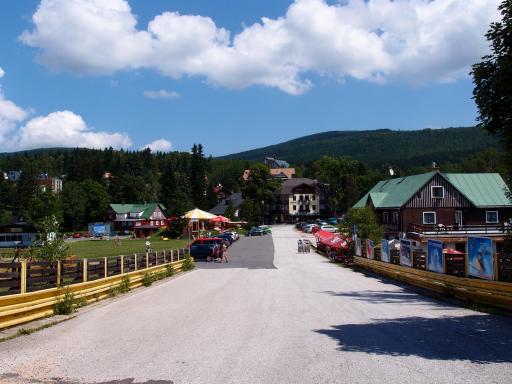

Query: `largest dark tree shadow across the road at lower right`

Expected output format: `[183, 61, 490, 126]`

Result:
[315, 315, 512, 364]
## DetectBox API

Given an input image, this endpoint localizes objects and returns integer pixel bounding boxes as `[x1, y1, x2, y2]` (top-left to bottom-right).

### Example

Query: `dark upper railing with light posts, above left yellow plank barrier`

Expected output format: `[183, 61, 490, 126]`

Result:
[0, 249, 188, 296]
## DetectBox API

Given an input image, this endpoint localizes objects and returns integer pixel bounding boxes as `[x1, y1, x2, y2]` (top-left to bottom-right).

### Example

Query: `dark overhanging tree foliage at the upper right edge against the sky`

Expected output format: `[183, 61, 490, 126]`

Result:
[472, 0, 512, 172]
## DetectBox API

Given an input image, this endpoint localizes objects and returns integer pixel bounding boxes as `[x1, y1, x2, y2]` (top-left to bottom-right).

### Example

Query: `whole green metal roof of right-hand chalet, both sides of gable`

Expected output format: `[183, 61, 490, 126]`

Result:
[354, 172, 512, 208]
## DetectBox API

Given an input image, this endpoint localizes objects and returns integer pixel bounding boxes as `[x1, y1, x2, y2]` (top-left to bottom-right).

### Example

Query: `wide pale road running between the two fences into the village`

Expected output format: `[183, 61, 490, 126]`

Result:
[0, 226, 512, 384]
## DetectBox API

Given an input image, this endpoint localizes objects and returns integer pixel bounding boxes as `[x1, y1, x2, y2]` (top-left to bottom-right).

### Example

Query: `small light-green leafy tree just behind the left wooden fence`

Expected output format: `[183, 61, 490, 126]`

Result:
[29, 215, 69, 261]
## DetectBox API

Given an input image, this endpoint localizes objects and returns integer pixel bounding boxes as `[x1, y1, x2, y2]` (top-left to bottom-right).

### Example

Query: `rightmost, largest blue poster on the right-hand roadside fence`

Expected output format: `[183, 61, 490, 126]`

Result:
[468, 237, 494, 280]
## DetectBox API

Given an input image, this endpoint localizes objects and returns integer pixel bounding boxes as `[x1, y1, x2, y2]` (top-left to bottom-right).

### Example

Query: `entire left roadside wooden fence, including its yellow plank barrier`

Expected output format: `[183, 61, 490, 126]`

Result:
[0, 249, 189, 329]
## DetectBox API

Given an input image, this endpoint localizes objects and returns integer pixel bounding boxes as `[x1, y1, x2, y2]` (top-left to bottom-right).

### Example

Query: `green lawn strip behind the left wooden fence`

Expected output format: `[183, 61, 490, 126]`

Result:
[70, 239, 189, 258]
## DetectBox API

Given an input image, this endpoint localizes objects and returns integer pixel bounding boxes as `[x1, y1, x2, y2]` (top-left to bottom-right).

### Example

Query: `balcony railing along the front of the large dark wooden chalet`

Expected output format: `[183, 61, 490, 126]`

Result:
[408, 224, 509, 235]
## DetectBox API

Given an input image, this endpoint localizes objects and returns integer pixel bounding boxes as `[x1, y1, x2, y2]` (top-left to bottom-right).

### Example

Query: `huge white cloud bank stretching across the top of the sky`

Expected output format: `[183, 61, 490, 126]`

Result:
[20, 0, 500, 94]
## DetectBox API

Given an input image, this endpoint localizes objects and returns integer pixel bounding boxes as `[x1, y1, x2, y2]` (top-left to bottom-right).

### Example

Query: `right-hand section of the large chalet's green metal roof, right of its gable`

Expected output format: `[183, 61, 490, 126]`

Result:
[443, 173, 512, 207]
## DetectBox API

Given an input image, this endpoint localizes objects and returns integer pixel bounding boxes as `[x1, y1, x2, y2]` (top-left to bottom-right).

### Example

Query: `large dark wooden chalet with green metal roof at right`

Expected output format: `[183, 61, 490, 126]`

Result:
[354, 171, 512, 251]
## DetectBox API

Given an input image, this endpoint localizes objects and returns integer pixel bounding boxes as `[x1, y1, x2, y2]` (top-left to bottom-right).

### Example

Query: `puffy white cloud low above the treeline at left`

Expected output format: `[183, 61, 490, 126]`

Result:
[15, 111, 132, 149]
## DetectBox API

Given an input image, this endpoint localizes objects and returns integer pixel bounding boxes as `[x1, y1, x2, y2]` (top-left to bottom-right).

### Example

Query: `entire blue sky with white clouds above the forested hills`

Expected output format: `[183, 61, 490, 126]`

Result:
[0, 0, 500, 156]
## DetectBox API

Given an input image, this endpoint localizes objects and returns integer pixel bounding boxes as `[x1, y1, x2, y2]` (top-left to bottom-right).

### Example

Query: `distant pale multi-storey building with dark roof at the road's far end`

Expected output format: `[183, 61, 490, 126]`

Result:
[270, 178, 330, 223]
